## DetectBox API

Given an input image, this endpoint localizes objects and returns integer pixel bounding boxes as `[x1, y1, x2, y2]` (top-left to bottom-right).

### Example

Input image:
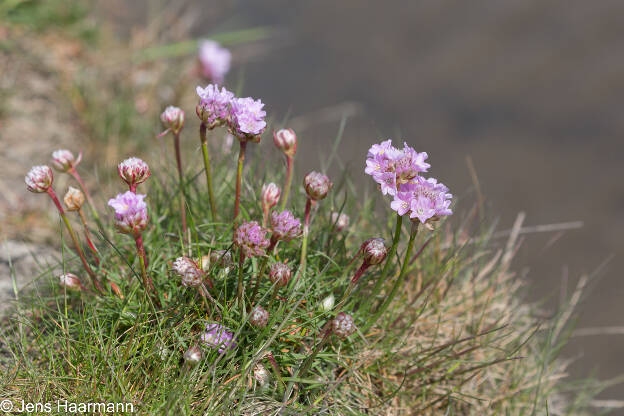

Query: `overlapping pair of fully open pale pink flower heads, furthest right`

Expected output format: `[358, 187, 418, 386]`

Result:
[364, 140, 453, 223]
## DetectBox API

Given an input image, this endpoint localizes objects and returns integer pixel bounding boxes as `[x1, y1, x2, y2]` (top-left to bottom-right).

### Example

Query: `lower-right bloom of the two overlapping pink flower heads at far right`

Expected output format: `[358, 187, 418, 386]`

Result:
[390, 176, 453, 224]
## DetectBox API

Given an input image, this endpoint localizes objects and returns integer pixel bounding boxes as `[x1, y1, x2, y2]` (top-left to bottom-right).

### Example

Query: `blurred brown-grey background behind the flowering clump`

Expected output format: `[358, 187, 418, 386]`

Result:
[0, 0, 624, 399]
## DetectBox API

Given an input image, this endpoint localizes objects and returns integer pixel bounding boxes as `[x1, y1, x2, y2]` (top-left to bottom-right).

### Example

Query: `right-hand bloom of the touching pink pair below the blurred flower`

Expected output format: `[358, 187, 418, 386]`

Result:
[229, 97, 266, 142]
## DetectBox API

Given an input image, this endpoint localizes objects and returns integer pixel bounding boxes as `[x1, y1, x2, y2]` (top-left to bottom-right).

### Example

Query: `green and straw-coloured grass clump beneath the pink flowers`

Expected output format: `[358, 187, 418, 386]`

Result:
[0, 125, 600, 415]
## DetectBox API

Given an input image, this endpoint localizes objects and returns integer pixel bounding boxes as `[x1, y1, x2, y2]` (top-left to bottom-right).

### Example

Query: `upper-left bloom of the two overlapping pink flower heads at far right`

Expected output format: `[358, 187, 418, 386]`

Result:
[364, 140, 430, 195]
